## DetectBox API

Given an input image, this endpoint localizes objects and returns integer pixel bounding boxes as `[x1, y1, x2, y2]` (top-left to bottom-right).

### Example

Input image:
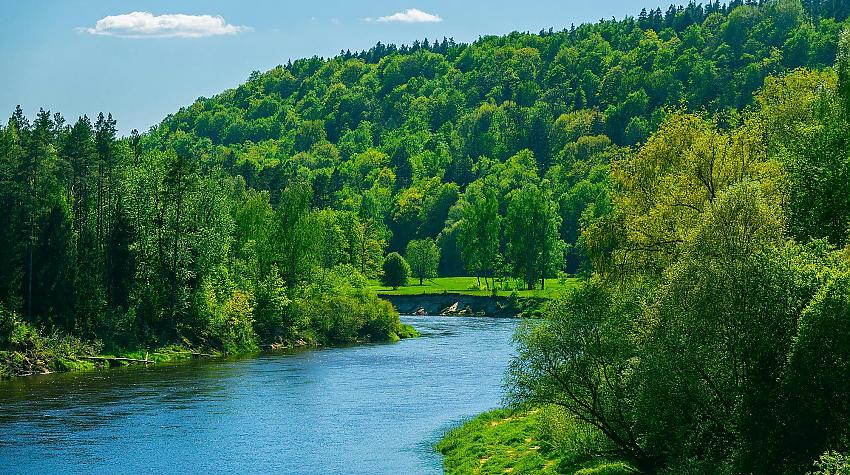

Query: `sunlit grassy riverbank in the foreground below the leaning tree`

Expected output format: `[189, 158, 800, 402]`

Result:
[436, 407, 634, 475]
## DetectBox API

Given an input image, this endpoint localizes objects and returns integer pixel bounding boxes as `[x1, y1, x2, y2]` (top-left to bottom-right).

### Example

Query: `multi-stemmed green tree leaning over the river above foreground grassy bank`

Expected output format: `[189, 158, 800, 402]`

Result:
[508, 281, 652, 471]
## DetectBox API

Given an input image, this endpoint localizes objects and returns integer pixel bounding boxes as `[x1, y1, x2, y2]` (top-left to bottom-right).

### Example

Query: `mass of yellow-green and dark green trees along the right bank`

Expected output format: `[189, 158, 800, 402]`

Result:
[509, 32, 850, 474]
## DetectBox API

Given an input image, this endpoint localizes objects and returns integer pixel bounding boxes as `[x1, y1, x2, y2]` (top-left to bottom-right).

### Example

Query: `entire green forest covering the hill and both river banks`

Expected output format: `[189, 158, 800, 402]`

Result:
[0, 0, 850, 473]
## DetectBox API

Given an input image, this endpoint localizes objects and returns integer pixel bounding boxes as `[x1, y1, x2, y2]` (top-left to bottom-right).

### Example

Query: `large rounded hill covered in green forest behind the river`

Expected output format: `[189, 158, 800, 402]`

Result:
[145, 0, 848, 275]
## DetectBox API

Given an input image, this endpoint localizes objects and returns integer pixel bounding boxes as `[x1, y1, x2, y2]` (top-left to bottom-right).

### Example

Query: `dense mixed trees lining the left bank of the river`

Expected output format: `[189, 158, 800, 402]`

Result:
[0, 108, 408, 368]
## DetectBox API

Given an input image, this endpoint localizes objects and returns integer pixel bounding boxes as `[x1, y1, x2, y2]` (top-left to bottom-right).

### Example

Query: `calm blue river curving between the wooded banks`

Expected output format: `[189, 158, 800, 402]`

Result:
[0, 317, 516, 474]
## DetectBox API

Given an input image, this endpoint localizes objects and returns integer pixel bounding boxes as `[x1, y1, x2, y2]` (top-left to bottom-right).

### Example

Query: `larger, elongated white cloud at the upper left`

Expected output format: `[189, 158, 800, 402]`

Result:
[79, 12, 246, 38]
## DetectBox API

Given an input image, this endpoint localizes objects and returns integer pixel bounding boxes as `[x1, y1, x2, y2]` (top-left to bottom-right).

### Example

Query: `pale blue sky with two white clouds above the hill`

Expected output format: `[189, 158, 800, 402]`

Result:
[0, 0, 678, 133]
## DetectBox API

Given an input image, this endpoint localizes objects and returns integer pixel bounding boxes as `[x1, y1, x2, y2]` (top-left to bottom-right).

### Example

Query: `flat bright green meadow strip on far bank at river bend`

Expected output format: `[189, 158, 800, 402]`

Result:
[369, 277, 579, 298]
